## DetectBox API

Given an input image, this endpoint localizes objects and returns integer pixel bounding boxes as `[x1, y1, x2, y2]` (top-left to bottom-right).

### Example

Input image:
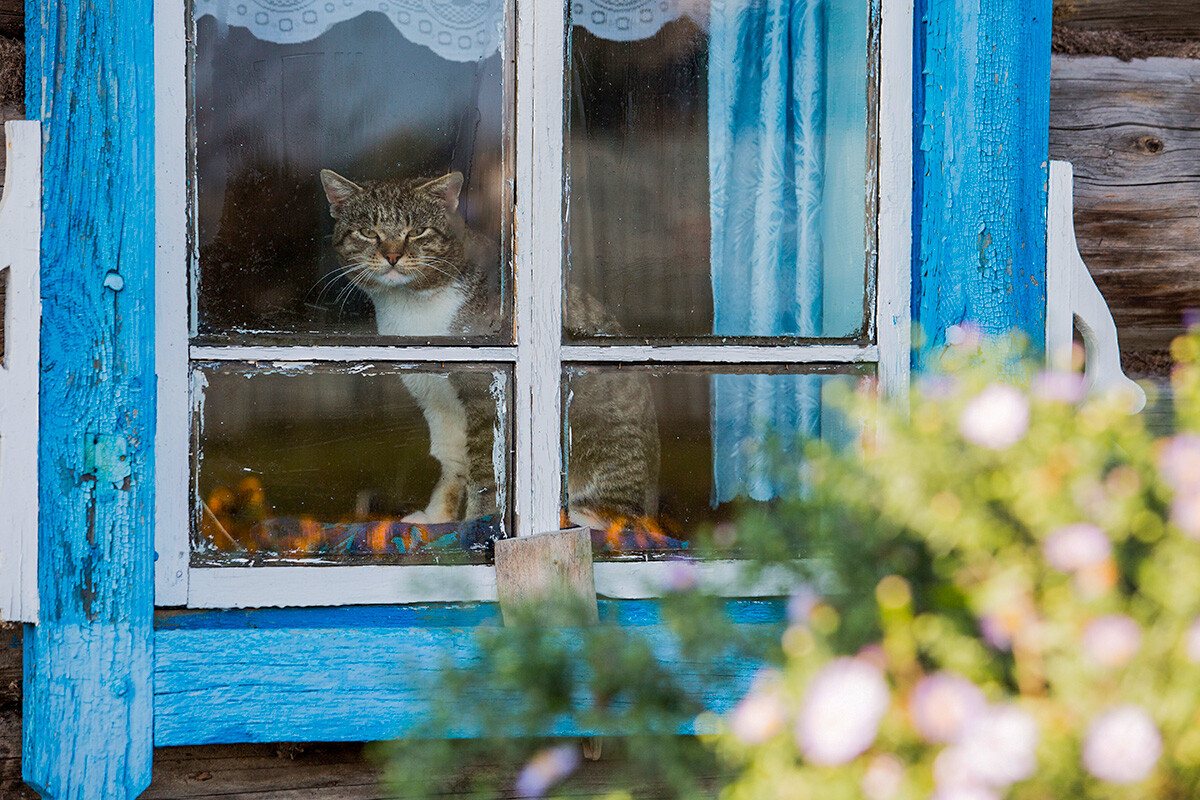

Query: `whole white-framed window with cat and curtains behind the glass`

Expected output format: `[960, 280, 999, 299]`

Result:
[156, 0, 911, 607]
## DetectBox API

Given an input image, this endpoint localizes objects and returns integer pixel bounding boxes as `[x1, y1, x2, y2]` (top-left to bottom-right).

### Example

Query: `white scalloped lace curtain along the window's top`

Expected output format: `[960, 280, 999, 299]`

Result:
[196, 0, 708, 61]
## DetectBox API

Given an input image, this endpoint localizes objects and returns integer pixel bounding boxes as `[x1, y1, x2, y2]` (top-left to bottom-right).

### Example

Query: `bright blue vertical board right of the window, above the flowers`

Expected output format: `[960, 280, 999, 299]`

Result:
[912, 0, 1051, 353]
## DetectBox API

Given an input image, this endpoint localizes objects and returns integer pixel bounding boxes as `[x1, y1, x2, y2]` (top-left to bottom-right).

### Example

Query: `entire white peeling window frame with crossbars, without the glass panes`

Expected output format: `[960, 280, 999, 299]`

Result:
[155, 0, 913, 608]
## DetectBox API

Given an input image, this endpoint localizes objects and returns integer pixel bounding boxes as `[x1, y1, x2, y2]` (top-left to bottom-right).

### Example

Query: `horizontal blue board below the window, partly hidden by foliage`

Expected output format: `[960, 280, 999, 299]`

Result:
[155, 601, 784, 745]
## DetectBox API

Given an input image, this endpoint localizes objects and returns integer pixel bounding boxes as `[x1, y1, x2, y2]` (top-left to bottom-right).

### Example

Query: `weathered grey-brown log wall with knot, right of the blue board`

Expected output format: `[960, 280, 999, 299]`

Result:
[1050, 56, 1200, 365]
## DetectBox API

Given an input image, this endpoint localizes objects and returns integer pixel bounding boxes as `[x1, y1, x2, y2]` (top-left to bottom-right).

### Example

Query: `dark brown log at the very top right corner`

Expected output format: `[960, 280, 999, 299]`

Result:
[1054, 0, 1200, 40]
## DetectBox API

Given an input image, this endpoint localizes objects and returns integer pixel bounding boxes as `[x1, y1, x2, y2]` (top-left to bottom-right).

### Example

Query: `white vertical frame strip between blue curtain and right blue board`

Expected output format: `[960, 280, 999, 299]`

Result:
[875, 0, 913, 399]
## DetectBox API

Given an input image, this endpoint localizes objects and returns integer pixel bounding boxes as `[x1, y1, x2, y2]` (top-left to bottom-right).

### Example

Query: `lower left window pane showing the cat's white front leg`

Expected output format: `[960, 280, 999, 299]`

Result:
[192, 363, 509, 564]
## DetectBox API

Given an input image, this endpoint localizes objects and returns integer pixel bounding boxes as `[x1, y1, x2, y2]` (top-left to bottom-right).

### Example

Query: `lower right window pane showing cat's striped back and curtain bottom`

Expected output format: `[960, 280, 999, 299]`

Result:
[564, 366, 864, 557]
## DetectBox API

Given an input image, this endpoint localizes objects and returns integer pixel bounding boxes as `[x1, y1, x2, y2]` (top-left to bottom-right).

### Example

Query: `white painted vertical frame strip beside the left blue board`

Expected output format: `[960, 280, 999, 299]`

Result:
[154, 0, 191, 606]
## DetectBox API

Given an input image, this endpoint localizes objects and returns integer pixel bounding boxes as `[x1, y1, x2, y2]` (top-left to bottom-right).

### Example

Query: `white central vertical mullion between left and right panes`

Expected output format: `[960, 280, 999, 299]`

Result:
[515, 0, 565, 535]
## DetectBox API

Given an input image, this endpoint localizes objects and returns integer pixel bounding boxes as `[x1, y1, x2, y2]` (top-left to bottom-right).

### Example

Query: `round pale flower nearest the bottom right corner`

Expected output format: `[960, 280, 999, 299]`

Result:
[1084, 705, 1163, 783]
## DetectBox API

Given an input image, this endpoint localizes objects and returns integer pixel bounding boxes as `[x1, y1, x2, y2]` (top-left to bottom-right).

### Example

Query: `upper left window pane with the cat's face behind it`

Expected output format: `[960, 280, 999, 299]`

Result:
[192, 0, 511, 341]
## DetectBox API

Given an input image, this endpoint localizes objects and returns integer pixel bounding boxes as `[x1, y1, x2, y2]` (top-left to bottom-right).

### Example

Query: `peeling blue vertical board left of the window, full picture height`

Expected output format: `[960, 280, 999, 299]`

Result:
[23, 0, 155, 800]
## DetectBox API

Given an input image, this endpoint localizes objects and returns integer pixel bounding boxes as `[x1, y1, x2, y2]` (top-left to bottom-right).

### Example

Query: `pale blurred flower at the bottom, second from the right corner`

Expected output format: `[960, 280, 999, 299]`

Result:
[950, 705, 1038, 788]
